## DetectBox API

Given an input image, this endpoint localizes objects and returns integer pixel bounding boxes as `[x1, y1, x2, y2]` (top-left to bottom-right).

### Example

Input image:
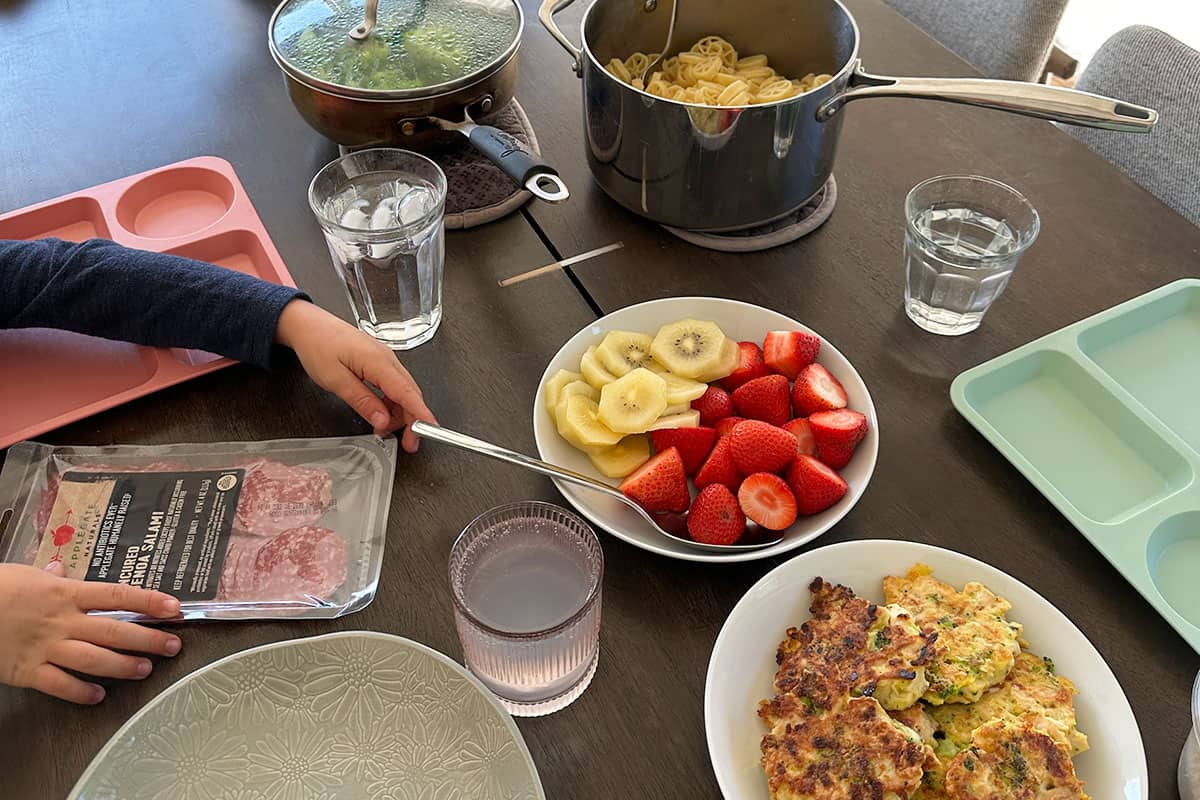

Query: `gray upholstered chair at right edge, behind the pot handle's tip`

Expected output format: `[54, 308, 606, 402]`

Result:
[1063, 25, 1200, 225]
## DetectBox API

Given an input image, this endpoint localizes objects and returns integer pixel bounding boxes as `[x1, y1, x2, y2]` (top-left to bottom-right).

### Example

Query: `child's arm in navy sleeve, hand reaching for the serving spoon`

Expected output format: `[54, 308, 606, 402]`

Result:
[0, 239, 436, 452]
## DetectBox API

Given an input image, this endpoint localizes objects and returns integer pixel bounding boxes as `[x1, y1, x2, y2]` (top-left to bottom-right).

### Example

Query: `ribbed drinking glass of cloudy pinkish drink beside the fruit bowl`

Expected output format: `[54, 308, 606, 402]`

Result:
[450, 500, 604, 716]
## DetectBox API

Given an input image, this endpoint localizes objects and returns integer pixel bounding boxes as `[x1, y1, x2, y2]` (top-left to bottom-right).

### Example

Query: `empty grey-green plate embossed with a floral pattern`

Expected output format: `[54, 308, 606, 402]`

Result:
[70, 631, 546, 800]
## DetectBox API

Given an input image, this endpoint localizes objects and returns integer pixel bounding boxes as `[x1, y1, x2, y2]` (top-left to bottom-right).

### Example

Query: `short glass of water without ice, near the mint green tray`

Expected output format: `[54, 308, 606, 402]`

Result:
[904, 175, 1040, 336]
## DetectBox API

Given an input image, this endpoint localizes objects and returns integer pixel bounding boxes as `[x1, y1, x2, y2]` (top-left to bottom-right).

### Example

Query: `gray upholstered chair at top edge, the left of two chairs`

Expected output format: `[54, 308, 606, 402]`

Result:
[887, 0, 1067, 80]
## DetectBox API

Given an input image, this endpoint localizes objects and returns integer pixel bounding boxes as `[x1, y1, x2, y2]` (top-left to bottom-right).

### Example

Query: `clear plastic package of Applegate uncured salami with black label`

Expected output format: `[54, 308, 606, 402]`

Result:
[0, 435, 396, 619]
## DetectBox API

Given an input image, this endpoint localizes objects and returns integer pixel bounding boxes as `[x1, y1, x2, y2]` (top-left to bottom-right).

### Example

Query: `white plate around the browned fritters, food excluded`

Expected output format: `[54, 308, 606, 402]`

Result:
[704, 541, 1150, 800]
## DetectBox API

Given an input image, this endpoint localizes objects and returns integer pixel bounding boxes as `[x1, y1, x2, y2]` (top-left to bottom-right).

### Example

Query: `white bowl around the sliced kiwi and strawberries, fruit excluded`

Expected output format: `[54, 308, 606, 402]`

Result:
[533, 297, 880, 561]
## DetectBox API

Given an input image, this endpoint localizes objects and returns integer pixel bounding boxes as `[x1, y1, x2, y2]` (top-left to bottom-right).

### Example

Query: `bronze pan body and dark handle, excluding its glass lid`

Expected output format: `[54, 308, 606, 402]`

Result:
[268, 0, 570, 203]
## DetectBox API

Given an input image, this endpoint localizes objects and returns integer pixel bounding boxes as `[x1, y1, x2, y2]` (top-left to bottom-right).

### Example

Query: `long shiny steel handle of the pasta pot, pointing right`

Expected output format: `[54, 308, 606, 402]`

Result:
[817, 66, 1158, 133]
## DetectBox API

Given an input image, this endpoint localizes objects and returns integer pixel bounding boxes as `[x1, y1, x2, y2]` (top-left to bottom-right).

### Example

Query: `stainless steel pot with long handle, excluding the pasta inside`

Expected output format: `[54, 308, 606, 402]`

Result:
[539, 0, 1158, 230]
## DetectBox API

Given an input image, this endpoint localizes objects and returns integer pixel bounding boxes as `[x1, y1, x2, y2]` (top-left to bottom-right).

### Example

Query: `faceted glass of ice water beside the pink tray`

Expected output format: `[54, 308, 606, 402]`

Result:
[308, 148, 446, 350]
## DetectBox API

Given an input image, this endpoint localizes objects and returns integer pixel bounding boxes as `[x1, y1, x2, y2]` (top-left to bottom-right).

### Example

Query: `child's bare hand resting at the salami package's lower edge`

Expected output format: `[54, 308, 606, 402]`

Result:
[0, 564, 180, 704]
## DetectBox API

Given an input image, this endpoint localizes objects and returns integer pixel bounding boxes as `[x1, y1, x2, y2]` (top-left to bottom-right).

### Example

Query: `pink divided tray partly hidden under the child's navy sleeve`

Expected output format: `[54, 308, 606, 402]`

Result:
[0, 156, 295, 449]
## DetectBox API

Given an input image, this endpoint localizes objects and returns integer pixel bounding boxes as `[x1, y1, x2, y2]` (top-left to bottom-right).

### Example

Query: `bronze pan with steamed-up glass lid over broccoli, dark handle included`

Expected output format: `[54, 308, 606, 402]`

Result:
[268, 0, 569, 203]
